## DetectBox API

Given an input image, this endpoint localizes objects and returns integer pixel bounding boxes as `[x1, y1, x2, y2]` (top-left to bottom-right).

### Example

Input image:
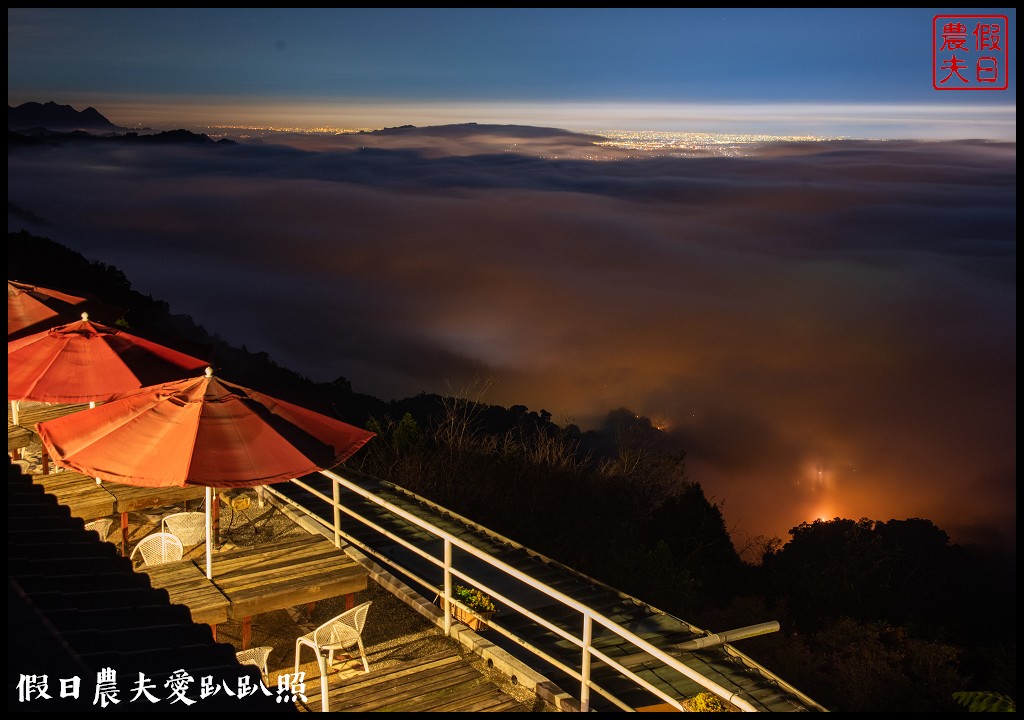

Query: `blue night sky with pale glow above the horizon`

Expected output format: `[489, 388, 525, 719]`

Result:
[7, 8, 1017, 139]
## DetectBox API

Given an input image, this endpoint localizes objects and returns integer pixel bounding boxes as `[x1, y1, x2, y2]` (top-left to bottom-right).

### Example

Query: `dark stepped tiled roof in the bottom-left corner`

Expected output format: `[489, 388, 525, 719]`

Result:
[7, 463, 297, 714]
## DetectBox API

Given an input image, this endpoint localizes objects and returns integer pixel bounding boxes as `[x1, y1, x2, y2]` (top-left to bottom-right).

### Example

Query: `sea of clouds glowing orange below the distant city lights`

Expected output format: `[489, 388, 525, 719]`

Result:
[8, 127, 1016, 543]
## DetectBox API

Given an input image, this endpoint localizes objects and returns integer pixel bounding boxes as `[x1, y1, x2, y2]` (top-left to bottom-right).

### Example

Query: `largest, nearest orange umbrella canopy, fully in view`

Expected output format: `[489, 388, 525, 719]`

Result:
[37, 369, 375, 489]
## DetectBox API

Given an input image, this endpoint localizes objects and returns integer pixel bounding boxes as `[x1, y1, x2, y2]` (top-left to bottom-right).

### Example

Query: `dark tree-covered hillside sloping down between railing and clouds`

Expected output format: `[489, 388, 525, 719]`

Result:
[7, 231, 1016, 712]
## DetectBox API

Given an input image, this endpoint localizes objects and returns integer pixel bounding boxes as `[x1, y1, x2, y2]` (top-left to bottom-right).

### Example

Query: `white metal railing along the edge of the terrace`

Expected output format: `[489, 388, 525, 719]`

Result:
[272, 470, 758, 712]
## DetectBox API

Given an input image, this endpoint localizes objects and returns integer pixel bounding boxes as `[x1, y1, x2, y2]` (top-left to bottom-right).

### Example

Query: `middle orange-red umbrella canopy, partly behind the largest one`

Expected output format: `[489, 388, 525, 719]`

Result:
[7, 312, 209, 404]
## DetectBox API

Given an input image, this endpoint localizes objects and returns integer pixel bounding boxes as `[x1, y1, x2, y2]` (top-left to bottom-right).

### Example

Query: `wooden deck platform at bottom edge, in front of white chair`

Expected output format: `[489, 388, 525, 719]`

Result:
[296, 652, 536, 713]
